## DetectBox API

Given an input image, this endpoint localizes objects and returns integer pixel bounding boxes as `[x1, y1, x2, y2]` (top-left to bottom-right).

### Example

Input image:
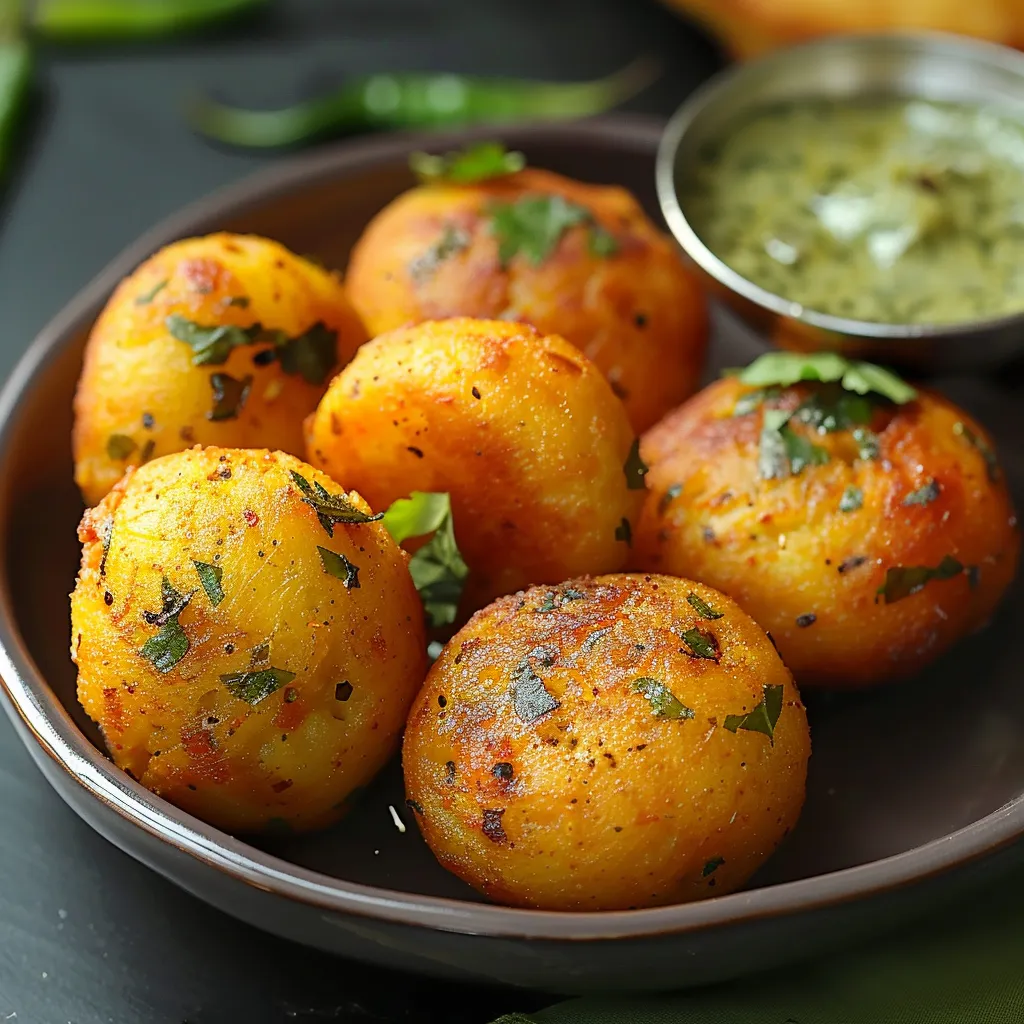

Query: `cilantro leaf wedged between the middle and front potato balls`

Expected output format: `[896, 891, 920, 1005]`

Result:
[383, 490, 469, 626]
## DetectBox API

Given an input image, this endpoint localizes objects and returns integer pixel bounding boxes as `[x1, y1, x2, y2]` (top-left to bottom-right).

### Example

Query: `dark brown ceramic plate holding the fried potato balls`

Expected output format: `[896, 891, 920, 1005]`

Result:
[0, 118, 1024, 992]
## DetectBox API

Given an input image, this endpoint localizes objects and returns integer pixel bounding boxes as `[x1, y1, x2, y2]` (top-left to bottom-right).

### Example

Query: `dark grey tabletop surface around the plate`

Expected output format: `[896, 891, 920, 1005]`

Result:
[0, 0, 720, 1024]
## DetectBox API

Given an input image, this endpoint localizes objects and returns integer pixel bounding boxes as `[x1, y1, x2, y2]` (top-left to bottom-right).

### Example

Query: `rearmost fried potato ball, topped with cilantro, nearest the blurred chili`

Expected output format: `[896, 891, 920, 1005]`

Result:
[346, 170, 708, 431]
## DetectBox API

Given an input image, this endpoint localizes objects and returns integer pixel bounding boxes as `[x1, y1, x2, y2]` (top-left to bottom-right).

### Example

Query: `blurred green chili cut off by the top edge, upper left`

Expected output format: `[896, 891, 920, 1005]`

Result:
[27, 0, 267, 43]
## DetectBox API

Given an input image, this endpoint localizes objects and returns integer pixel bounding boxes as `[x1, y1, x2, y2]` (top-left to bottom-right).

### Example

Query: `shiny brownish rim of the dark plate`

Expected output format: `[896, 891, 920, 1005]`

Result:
[0, 116, 1024, 941]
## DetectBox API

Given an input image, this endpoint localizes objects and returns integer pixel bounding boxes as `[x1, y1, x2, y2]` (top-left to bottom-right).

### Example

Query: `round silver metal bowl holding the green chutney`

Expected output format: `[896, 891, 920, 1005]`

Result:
[656, 33, 1024, 372]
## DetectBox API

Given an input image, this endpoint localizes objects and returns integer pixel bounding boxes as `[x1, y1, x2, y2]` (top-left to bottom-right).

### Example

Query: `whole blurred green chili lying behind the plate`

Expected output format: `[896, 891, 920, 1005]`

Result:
[189, 59, 657, 148]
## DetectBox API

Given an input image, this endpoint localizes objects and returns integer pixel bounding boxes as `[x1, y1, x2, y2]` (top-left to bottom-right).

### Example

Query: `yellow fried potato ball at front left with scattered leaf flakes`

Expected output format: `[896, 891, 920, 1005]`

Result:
[72, 447, 426, 831]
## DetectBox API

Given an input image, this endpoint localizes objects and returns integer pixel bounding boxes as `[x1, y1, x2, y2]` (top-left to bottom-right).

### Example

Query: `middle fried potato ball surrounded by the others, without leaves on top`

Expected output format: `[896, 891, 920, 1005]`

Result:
[307, 318, 643, 610]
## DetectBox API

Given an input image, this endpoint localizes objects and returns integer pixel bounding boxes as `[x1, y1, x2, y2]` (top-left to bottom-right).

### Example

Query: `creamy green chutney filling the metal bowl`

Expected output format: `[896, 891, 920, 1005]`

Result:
[681, 99, 1024, 324]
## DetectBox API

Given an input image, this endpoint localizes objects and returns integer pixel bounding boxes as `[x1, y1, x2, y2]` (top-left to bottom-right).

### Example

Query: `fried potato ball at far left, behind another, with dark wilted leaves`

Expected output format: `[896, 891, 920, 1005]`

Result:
[73, 234, 367, 505]
